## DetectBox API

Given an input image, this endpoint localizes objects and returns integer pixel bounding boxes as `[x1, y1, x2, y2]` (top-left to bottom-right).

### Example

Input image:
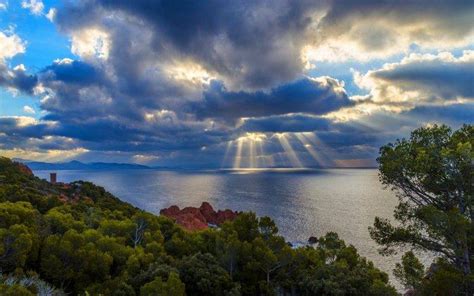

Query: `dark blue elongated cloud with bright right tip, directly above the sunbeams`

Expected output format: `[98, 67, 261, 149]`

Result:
[194, 77, 352, 120]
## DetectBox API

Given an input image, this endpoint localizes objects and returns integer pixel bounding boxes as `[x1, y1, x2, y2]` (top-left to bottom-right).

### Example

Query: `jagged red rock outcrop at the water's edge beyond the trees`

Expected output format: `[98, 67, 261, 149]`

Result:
[160, 202, 238, 231]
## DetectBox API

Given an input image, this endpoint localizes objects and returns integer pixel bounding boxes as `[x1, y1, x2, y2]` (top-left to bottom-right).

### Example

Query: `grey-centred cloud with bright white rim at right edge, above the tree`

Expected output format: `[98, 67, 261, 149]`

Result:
[355, 51, 474, 108]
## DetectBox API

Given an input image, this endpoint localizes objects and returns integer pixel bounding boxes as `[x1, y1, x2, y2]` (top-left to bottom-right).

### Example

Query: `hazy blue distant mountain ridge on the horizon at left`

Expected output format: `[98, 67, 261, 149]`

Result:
[14, 159, 151, 170]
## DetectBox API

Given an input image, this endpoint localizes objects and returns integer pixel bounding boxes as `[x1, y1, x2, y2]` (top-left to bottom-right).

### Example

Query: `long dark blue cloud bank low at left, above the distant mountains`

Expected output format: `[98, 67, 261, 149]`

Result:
[0, 117, 229, 152]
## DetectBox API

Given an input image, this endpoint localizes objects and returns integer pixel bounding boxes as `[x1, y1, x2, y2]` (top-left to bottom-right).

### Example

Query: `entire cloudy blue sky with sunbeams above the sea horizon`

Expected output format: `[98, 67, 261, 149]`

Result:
[0, 0, 474, 169]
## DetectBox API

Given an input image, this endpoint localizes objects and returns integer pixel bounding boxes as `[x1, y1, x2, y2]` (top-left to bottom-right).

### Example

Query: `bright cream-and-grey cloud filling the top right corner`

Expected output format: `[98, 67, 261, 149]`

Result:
[309, 0, 474, 62]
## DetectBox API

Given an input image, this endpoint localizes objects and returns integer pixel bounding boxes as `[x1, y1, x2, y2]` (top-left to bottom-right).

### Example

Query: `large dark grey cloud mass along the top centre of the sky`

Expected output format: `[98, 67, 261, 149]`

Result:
[56, 0, 321, 88]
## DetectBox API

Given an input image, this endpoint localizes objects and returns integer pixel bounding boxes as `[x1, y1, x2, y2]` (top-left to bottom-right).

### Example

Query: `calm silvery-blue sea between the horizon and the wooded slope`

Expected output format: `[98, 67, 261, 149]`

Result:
[35, 169, 412, 286]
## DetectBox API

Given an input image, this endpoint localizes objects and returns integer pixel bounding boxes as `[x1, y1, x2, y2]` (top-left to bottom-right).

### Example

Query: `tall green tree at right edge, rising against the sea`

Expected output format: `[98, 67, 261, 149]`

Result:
[370, 125, 474, 294]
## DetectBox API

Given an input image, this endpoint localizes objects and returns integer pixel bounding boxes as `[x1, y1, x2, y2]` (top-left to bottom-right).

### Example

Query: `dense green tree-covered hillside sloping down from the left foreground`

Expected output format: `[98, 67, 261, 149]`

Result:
[0, 158, 396, 296]
